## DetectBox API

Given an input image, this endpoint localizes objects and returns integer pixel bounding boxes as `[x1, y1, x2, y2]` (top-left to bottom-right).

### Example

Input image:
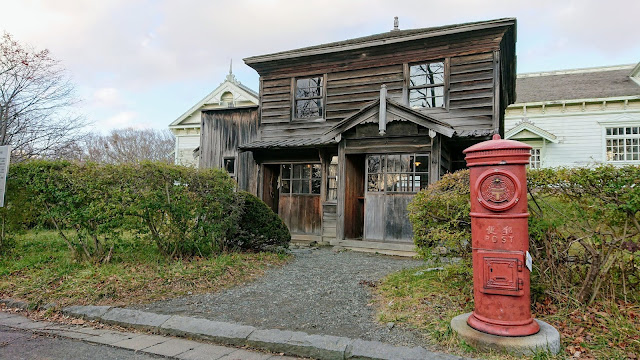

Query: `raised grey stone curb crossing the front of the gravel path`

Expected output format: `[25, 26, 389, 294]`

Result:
[63, 306, 464, 360]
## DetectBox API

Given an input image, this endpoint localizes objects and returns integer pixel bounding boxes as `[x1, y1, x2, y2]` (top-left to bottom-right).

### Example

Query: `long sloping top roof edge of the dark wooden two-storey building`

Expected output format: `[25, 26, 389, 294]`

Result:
[244, 18, 516, 67]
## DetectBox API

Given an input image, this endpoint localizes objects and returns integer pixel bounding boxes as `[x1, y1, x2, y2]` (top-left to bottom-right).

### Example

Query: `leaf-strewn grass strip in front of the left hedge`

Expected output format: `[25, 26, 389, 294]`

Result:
[0, 231, 289, 308]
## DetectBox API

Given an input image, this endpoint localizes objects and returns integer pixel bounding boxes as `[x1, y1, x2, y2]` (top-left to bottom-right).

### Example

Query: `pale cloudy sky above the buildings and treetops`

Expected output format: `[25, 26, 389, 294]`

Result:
[0, 0, 640, 90]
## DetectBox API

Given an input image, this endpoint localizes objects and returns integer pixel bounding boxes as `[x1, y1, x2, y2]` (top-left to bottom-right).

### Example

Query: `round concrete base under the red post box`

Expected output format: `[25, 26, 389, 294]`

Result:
[451, 313, 560, 355]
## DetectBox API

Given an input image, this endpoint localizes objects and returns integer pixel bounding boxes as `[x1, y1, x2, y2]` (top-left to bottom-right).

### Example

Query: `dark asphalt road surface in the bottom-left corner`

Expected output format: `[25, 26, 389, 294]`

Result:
[0, 325, 166, 360]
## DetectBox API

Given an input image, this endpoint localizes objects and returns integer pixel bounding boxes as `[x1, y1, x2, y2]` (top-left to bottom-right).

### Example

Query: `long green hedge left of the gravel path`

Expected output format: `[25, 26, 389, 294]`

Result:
[0, 161, 290, 262]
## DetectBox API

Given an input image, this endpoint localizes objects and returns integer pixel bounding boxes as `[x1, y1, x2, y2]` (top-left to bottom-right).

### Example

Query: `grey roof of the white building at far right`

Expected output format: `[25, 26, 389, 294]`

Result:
[516, 64, 640, 104]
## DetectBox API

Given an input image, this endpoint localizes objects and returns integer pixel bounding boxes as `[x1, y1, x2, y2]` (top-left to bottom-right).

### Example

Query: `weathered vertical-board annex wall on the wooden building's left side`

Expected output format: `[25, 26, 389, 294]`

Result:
[200, 107, 258, 194]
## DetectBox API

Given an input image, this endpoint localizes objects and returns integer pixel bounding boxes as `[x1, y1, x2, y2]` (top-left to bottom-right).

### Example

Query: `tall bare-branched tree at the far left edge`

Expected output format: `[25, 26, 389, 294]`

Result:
[0, 32, 86, 161]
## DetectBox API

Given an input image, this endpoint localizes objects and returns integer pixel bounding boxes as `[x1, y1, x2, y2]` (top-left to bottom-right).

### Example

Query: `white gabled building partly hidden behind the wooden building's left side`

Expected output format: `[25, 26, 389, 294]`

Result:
[169, 69, 259, 167]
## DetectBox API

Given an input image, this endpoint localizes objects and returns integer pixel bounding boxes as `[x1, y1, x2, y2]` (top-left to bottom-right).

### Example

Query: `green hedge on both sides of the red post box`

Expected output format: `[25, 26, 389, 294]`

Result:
[409, 166, 640, 303]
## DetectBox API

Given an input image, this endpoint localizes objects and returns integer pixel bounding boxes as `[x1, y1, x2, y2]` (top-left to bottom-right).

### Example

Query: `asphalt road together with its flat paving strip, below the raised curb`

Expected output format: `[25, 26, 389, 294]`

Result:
[0, 311, 295, 360]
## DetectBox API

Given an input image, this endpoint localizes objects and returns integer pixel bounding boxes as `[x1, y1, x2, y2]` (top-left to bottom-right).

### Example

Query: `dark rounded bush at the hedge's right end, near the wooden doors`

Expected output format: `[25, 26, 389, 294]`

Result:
[232, 191, 291, 251]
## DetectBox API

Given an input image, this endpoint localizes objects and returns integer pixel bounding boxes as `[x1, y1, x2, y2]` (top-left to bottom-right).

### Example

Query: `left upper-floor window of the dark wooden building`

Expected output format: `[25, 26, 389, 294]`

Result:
[294, 76, 324, 119]
